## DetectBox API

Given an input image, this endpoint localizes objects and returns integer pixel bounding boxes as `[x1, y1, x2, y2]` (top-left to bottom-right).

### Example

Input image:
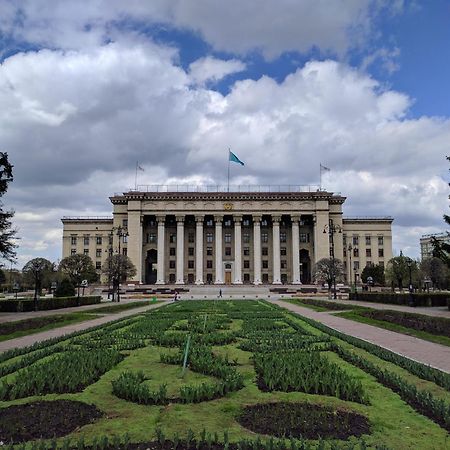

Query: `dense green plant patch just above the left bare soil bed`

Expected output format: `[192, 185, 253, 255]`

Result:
[0, 349, 123, 400]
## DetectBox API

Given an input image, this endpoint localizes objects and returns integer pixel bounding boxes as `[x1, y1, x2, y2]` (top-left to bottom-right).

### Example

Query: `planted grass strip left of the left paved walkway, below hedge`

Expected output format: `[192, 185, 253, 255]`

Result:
[0, 313, 99, 342]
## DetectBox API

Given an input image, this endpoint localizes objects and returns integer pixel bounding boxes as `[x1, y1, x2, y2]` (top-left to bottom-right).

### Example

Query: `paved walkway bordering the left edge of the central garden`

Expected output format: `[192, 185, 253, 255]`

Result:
[0, 302, 167, 353]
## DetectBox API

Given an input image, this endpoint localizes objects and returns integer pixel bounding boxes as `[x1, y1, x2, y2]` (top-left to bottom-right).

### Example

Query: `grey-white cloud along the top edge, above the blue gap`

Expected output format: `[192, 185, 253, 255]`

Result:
[0, 0, 402, 58]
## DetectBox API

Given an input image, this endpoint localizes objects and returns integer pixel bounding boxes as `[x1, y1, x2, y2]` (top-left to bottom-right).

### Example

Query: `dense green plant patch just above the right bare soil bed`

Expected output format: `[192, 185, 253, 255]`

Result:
[254, 350, 369, 404]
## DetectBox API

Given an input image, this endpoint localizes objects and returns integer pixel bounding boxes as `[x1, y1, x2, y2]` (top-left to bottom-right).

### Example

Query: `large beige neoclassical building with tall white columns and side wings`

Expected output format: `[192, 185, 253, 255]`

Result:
[62, 187, 393, 285]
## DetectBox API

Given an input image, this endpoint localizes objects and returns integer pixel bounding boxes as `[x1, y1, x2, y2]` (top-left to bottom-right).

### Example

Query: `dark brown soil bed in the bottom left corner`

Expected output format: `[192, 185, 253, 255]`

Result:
[0, 400, 103, 443]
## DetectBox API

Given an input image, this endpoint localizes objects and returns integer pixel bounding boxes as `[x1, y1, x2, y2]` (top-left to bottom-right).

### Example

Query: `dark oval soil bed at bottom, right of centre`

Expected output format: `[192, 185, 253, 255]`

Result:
[237, 402, 370, 439]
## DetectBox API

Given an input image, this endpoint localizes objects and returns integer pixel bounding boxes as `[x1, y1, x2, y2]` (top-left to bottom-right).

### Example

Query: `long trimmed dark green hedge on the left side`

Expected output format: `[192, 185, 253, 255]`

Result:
[0, 296, 102, 312]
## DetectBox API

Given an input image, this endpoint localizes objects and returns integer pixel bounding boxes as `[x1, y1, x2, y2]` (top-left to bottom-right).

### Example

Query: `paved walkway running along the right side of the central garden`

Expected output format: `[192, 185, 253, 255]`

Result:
[269, 300, 450, 373]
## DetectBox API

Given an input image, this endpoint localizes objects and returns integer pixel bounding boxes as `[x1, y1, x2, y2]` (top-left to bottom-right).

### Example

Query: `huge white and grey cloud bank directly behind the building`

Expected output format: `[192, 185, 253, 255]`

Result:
[0, 40, 450, 261]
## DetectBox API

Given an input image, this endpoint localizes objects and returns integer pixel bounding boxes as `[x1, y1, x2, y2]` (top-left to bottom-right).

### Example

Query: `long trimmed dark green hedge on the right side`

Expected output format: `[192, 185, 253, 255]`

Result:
[349, 292, 450, 306]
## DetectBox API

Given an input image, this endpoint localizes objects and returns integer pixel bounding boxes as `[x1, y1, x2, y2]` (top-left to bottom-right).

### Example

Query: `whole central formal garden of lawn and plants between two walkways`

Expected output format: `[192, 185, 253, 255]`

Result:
[0, 300, 450, 450]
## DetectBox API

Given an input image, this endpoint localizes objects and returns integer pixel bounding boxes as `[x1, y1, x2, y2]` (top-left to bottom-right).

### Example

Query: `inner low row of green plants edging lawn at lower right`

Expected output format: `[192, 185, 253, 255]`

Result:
[333, 344, 450, 432]
